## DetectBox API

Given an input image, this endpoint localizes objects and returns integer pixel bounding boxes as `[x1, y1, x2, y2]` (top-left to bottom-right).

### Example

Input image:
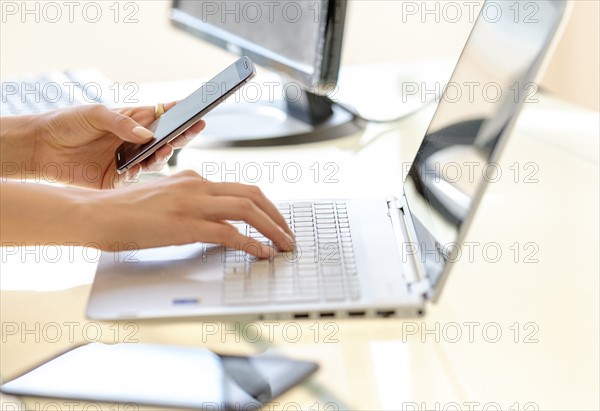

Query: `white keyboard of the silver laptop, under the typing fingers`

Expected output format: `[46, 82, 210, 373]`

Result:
[223, 201, 360, 305]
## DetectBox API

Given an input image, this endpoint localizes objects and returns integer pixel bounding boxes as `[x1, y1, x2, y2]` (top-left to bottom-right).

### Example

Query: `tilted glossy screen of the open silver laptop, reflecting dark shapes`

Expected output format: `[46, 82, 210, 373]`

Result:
[404, 0, 566, 296]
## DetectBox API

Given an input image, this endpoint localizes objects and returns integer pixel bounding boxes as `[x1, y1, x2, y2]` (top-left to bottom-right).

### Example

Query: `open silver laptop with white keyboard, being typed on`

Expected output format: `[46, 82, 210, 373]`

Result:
[87, 0, 567, 320]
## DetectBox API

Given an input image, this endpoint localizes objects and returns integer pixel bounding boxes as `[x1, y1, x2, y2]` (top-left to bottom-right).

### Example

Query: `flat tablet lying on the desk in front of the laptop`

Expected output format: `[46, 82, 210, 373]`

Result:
[0, 343, 318, 410]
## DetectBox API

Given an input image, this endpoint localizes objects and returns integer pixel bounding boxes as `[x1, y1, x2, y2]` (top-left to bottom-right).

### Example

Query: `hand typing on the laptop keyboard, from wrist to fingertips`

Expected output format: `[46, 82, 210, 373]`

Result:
[84, 171, 294, 258]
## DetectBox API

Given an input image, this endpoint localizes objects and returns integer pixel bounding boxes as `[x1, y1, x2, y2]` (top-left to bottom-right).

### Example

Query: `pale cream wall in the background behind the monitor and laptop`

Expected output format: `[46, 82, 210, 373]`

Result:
[0, 0, 600, 110]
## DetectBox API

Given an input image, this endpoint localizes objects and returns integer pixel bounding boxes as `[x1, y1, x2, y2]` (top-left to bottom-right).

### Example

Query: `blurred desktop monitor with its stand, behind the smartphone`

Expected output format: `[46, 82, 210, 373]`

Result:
[170, 0, 361, 145]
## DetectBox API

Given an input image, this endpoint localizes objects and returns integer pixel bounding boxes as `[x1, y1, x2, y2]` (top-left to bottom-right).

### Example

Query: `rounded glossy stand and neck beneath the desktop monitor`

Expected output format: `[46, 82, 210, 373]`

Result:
[185, 87, 365, 147]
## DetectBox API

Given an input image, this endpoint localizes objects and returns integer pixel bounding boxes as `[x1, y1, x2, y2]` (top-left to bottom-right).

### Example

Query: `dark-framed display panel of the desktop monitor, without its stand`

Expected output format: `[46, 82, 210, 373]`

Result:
[171, 0, 346, 91]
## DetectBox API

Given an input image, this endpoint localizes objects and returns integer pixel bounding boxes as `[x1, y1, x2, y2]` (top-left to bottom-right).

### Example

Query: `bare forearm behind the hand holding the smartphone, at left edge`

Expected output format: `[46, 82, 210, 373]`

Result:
[0, 115, 38, 180]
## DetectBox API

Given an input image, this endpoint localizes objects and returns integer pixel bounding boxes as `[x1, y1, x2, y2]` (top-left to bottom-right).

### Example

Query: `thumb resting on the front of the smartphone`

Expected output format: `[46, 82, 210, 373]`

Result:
[91, 105, 154, 144]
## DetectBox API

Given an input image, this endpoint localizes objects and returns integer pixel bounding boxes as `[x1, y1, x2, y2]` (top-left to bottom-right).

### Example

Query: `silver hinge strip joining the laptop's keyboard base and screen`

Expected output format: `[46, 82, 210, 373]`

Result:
[388, 198, 431, 298]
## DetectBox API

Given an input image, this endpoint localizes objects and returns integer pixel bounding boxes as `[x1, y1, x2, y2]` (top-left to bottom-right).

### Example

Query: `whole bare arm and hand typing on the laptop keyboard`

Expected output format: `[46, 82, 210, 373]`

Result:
[0, 171, 294, 258]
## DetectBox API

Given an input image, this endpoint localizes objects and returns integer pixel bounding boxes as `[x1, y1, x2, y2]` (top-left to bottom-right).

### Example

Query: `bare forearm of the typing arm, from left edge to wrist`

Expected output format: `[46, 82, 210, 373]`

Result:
[0, 180, 94, 246]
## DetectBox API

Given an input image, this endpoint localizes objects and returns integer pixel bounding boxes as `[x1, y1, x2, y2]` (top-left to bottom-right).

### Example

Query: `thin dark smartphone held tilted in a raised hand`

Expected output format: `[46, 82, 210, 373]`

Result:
[115, 57, 256, 173]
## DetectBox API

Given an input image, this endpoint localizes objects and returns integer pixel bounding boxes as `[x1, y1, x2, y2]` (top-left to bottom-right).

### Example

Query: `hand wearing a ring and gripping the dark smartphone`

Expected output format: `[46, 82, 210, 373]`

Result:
[30, 102, 204, 189]
